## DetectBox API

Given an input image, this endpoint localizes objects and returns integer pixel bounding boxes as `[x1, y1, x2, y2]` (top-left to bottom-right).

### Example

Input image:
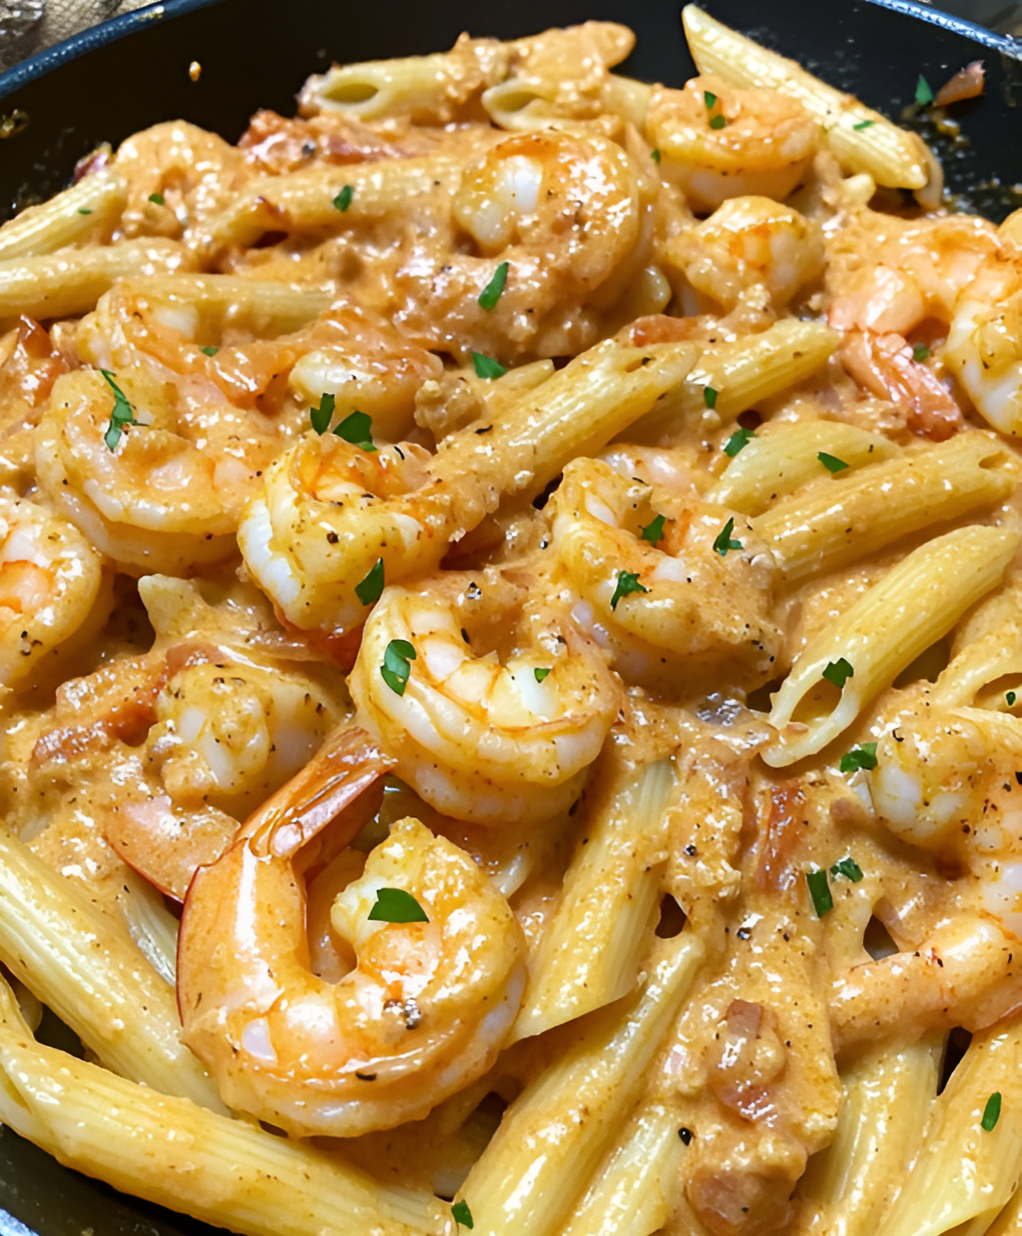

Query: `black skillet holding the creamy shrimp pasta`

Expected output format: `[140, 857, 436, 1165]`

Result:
[0, 0, 1022, 1236]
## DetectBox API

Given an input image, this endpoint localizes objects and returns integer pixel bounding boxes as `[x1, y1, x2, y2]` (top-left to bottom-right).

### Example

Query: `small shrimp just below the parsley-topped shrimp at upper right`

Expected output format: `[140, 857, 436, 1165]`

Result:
[665, 197, 823, 313]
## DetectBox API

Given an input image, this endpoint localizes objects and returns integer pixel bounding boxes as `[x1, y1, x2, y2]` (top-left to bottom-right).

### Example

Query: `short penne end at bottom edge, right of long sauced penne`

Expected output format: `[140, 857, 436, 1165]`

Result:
[564, 1103, 685, 1236]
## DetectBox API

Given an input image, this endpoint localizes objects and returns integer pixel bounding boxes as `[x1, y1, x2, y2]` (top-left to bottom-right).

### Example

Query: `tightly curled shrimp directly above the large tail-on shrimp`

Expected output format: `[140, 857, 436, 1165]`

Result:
[348, 569, 620, 824]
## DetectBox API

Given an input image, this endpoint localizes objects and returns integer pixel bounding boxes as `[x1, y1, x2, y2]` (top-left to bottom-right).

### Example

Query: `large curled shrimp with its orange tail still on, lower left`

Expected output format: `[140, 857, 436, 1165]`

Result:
[178, 728, 525, 1137]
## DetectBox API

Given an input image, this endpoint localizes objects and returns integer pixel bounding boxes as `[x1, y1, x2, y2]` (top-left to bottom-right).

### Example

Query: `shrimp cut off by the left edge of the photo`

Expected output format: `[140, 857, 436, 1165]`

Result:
[0, 498, 114, 690]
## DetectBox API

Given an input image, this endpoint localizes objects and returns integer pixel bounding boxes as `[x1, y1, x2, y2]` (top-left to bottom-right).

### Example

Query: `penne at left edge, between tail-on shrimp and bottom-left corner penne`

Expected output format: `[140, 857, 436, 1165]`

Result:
[0, 832, 226, 1112]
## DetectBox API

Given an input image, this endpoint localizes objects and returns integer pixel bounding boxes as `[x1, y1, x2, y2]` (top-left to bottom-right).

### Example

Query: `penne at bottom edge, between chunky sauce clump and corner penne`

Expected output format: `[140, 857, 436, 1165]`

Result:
[797, 1035, 944, 1236]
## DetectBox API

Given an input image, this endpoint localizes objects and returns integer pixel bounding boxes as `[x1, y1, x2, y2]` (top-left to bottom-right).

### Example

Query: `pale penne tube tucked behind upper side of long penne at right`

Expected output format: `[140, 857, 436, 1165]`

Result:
[707, 420, 898, 515]
